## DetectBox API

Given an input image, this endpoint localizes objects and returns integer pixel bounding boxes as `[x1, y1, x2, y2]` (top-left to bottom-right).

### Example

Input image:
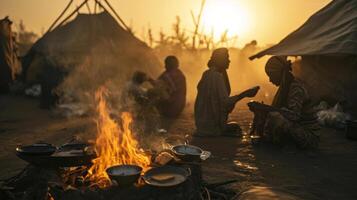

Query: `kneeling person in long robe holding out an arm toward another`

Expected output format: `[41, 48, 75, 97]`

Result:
[194, 48, 259, 136]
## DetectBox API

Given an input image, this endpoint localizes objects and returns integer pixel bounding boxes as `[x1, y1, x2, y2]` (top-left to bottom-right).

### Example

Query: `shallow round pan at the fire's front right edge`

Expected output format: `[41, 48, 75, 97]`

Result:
[143, 165, 191, 187]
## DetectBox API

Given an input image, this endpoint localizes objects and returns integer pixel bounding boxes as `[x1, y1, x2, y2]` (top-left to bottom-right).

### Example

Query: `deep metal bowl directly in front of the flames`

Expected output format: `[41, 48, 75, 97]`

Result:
[106, 165, 143, 186]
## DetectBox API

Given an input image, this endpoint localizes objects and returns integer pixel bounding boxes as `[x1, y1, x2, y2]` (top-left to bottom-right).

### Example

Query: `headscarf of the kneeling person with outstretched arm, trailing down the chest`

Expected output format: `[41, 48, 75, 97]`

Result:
[207, 48, 231, 95]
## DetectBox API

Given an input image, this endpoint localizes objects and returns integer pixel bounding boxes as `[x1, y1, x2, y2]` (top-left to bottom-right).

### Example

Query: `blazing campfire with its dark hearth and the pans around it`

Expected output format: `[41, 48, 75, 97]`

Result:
[0, 88, 239, 200]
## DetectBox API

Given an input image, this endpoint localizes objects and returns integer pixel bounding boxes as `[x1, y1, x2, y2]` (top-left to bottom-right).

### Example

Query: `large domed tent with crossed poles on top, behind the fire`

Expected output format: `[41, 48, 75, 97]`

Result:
[23, 1, 161, 106]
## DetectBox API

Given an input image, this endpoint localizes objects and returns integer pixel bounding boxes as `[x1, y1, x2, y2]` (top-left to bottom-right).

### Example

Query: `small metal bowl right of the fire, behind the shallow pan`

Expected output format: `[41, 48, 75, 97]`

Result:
[172, 145, 203, 162]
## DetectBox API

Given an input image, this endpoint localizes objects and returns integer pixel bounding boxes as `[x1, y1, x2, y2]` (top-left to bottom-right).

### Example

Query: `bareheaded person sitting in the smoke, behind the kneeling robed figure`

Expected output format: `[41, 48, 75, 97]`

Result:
[158, 56, 186, 118]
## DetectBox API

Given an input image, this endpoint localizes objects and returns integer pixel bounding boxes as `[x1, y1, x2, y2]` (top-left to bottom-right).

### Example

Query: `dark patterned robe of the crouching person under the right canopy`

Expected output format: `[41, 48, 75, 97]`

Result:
[266, 79, 319, 148]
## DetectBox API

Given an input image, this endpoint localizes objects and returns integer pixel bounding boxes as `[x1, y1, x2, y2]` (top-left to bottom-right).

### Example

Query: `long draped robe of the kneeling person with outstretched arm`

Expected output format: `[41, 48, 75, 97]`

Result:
[194, 68, 235, 136]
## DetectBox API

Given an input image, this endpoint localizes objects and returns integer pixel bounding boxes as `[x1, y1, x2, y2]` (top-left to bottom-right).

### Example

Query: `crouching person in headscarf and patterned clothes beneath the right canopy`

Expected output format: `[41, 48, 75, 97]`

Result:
[265, 56, 319, 148]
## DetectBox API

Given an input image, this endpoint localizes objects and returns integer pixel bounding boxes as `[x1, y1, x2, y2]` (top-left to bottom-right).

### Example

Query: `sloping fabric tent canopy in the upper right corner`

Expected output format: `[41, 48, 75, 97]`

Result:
[250, 0, 357, 59]
